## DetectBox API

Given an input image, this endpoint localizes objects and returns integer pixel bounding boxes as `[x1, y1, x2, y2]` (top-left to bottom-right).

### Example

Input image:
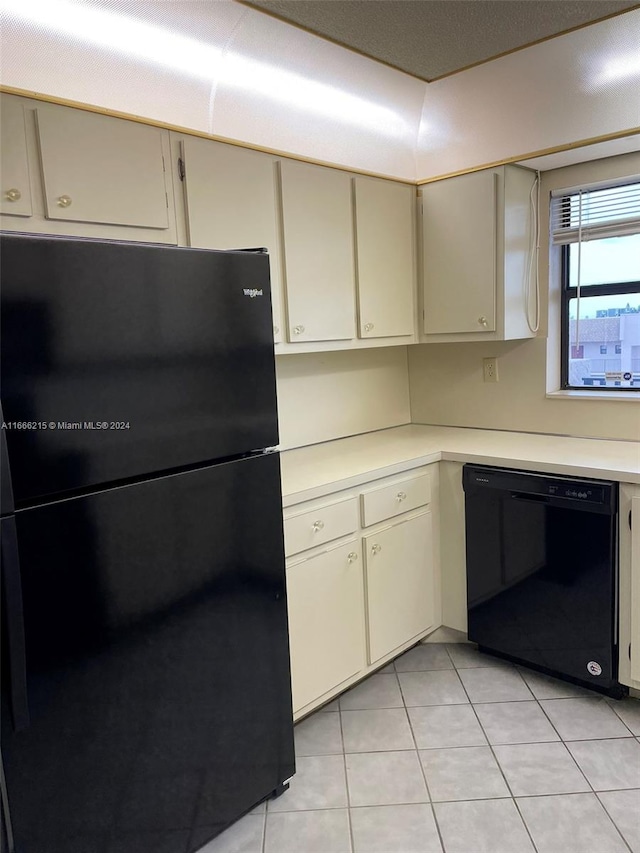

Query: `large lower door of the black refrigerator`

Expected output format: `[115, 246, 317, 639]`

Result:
[2, 454, 294, 853]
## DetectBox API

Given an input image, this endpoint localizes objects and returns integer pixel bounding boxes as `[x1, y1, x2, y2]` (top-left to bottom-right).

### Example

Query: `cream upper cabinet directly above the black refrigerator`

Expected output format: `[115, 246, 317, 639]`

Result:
[1, 95, 177, 243]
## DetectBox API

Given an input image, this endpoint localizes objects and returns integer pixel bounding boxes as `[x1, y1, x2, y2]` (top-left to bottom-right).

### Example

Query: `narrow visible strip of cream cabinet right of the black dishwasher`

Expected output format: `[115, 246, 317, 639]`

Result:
[619, 483, 640, 690]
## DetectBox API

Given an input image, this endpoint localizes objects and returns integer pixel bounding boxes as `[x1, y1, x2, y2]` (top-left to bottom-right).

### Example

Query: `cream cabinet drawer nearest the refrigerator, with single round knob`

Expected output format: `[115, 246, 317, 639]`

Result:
[284, 497, 358, 557]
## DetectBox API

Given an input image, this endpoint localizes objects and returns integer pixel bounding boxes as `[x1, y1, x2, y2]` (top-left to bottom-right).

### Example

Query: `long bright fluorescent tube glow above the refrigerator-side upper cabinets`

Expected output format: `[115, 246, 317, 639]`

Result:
[0, 0, 410, 137]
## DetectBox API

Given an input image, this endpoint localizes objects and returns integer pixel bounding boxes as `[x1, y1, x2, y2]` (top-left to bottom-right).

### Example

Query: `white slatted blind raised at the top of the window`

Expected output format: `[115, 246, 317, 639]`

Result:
[551, 181, 640, 246]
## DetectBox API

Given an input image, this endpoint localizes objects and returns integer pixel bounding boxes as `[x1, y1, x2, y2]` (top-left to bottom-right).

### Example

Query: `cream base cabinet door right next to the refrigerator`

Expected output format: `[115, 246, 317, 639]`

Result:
[287, 542, 365, 711]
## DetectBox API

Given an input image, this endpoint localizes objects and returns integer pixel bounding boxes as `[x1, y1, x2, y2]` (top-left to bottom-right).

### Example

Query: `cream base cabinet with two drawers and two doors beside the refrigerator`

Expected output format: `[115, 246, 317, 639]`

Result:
[284, 465, 439, 718]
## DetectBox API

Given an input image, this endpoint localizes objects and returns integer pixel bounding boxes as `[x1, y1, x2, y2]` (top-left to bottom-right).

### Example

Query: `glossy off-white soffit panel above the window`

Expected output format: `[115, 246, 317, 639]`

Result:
[416, 9, 640, 180]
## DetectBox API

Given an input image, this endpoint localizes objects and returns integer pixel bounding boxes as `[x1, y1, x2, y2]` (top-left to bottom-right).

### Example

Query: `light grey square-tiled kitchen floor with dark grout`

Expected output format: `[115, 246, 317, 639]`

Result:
[201, 644, 640, 853]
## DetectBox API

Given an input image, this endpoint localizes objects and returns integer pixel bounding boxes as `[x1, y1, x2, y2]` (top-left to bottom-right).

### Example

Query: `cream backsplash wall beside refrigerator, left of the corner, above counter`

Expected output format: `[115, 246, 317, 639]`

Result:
[276, 347, 410, 448]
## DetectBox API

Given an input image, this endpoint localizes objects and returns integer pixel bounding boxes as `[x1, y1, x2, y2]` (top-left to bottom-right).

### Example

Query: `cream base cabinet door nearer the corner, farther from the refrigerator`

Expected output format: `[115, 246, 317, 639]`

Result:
[364, 512, 435, 664]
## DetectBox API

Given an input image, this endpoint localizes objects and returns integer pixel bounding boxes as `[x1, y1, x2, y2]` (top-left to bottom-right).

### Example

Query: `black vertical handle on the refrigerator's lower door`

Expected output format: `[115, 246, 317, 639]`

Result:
[0, 516, 30, 732]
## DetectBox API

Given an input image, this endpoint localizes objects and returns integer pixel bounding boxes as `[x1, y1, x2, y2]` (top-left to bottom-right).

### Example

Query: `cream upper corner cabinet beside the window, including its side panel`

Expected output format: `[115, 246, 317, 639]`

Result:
[421, 166, 536, 341]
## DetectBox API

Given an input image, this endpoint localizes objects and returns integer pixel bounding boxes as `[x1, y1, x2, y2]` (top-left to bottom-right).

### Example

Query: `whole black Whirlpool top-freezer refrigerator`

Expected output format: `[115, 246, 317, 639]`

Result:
[0, 234, 294, 853]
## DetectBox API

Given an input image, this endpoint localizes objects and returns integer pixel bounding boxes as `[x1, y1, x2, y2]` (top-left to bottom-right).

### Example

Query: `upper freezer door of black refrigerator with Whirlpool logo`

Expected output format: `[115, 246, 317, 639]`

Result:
[0, 234, 278, 506]
